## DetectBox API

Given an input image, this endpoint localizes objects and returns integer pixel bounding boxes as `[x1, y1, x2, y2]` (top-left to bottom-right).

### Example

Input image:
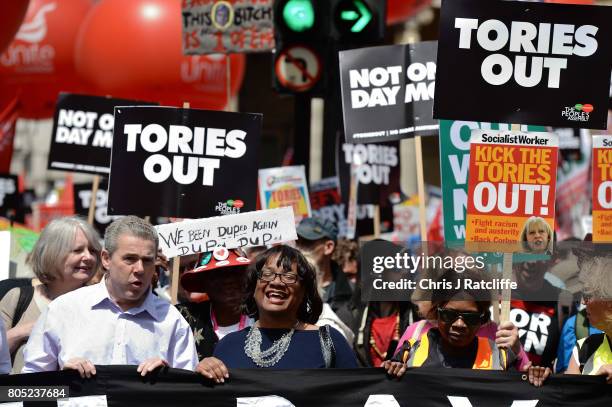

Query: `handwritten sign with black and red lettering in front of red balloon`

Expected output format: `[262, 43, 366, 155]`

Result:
[182, 0, 274, 55]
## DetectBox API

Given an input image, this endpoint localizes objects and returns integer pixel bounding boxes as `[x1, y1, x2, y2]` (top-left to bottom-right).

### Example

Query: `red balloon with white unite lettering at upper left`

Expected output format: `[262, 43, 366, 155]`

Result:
[0, 0, 92, 118]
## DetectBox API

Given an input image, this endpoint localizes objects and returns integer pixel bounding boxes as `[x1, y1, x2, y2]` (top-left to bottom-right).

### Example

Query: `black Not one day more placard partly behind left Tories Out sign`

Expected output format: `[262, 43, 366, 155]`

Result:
[47, 93, 156, 176]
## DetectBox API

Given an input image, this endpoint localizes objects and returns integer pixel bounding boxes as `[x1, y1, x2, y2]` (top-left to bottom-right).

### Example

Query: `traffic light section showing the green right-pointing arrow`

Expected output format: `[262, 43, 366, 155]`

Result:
[331, 0, 387, 44]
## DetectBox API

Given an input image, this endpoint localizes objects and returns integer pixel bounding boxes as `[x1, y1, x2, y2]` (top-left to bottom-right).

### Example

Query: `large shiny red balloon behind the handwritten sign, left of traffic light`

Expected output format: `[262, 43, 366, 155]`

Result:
[75, 0, 245, 109]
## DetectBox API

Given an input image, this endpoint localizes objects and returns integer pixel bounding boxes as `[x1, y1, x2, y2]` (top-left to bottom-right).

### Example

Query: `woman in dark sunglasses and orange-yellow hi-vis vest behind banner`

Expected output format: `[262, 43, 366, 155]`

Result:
[383, 270, 549, 386]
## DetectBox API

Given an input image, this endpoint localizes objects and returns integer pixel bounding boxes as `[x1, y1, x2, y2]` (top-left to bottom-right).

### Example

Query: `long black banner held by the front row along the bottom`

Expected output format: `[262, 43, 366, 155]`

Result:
[0, 366, 612, 407]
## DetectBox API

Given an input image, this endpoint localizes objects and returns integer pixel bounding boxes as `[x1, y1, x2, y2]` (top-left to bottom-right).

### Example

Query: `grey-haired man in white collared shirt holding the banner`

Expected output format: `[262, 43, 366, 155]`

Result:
[22, 216, 198, 377]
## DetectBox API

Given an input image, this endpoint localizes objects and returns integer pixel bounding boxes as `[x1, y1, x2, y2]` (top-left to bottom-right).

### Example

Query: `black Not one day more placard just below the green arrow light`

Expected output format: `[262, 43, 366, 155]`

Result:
[340, 41, 438, 143]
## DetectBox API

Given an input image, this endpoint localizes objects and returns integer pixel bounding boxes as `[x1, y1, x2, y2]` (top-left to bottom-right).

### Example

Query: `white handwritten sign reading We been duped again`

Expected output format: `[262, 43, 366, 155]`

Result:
[155, 207, 297, 258]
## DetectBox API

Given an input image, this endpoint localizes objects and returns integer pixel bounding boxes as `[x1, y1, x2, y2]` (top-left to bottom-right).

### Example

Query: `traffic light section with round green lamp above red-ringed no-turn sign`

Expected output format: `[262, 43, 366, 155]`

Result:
[274, 0, 331, 96]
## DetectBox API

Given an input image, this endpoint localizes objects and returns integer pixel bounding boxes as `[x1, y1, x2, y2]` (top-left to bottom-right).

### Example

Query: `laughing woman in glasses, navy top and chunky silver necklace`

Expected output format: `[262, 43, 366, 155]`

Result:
[196, 245, 357, 383]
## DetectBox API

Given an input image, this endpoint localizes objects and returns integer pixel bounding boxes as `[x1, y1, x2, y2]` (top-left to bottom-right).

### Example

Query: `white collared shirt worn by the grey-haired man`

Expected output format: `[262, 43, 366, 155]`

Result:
[22, 280, 198, 373]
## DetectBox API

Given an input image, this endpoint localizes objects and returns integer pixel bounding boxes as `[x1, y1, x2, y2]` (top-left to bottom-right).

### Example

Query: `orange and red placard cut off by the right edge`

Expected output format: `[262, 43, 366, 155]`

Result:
[592, 136, 612, 242]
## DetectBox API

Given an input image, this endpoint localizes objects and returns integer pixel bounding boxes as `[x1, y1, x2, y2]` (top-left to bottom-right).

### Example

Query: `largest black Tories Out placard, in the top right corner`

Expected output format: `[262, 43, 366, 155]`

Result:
[434, 0, 612, 129]
